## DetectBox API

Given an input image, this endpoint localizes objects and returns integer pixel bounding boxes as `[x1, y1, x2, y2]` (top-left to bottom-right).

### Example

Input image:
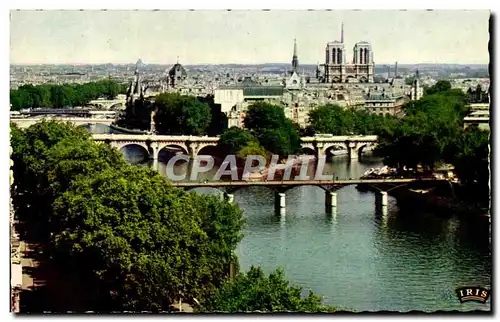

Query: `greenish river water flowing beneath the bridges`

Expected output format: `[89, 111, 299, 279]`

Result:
[88, 124, 492, 312]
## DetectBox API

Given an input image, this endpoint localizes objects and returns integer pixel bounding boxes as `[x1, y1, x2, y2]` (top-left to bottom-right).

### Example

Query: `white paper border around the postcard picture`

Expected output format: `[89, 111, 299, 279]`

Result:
[0, 0, 500, 321]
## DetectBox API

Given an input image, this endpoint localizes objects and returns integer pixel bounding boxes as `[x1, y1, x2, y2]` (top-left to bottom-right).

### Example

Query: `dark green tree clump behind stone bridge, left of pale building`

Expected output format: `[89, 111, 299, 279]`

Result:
[154, 93, 212, 135]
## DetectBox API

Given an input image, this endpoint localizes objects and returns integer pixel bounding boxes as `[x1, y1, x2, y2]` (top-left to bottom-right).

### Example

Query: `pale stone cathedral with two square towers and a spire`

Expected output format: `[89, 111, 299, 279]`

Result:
[317, 24, 375, 83]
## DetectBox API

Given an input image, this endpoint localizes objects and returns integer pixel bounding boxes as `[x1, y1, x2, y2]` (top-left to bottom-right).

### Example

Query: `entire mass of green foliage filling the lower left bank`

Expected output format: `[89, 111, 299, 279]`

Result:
[12, 122, 244, 311]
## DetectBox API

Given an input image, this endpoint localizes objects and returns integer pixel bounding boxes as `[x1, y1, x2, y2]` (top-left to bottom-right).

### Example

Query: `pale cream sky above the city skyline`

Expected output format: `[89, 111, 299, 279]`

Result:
[10, 10, 490, 65]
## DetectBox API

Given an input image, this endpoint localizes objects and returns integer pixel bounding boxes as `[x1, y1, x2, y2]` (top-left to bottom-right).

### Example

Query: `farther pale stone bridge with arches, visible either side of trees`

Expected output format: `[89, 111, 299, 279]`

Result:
[93, 134, 378, 160]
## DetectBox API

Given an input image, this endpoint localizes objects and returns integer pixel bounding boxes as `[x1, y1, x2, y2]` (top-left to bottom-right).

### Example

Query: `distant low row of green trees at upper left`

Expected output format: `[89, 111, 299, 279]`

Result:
[10, 79, 123, 111]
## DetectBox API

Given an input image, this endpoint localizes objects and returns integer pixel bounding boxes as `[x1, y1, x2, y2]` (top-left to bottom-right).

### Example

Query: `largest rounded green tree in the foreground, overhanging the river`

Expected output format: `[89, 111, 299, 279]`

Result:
[50, 166, 243, 311]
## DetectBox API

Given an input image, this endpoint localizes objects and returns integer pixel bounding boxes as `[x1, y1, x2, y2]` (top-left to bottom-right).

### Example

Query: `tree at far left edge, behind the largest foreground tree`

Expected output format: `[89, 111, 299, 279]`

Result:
[11, 121, 121, 239]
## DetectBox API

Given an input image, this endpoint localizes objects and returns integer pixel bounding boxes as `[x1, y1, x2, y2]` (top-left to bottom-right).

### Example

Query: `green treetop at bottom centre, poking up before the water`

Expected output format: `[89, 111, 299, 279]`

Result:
[202, 266, 336, 313]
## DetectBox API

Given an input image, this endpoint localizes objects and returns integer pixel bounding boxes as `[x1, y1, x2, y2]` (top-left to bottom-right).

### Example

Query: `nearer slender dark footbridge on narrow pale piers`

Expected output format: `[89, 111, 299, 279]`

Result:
[172, 178, 446, 214]
